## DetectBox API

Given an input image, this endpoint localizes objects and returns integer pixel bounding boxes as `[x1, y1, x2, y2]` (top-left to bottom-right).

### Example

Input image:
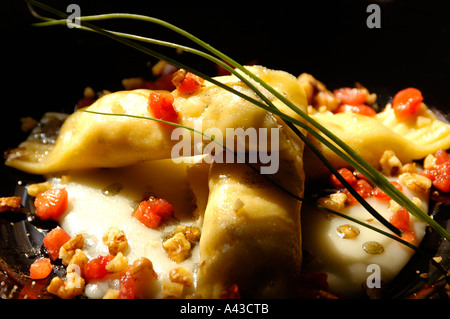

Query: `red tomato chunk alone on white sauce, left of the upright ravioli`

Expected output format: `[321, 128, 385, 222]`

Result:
[134, 198, 173, 228]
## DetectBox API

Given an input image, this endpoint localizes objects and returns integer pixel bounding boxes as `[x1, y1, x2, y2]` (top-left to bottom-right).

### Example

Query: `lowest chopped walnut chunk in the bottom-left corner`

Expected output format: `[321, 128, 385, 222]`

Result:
[47, 272, 86, 299]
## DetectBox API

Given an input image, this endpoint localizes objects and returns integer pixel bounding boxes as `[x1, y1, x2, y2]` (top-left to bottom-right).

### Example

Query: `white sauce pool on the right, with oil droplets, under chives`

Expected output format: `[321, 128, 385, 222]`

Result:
[302, 179, 428, 296]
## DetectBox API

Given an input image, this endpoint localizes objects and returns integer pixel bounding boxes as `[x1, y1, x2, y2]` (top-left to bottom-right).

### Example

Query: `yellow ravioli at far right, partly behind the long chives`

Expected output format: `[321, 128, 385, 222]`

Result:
[305, 105, 450, 178]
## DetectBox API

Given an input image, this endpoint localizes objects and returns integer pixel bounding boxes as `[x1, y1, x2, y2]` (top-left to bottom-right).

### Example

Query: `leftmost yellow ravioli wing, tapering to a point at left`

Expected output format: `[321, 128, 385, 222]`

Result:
[6, 90, 177, 174]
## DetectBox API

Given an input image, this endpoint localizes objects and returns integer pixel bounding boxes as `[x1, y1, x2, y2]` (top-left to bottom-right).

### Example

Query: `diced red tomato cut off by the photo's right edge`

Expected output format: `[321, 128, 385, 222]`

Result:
[422, 150, 450, 193]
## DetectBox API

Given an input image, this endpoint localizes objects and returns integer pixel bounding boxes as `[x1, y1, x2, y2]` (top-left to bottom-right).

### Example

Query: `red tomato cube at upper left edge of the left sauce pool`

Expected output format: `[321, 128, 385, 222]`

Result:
[34, 188, 68, 220]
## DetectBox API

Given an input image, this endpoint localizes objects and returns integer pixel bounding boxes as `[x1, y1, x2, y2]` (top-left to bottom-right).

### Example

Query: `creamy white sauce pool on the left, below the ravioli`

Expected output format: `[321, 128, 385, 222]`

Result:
[49, 160, 203, 298]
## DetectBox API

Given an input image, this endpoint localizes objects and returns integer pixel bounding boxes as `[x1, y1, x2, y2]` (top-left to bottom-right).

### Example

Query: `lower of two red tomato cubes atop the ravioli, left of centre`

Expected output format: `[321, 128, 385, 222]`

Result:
[148, 92, 178, 127]
